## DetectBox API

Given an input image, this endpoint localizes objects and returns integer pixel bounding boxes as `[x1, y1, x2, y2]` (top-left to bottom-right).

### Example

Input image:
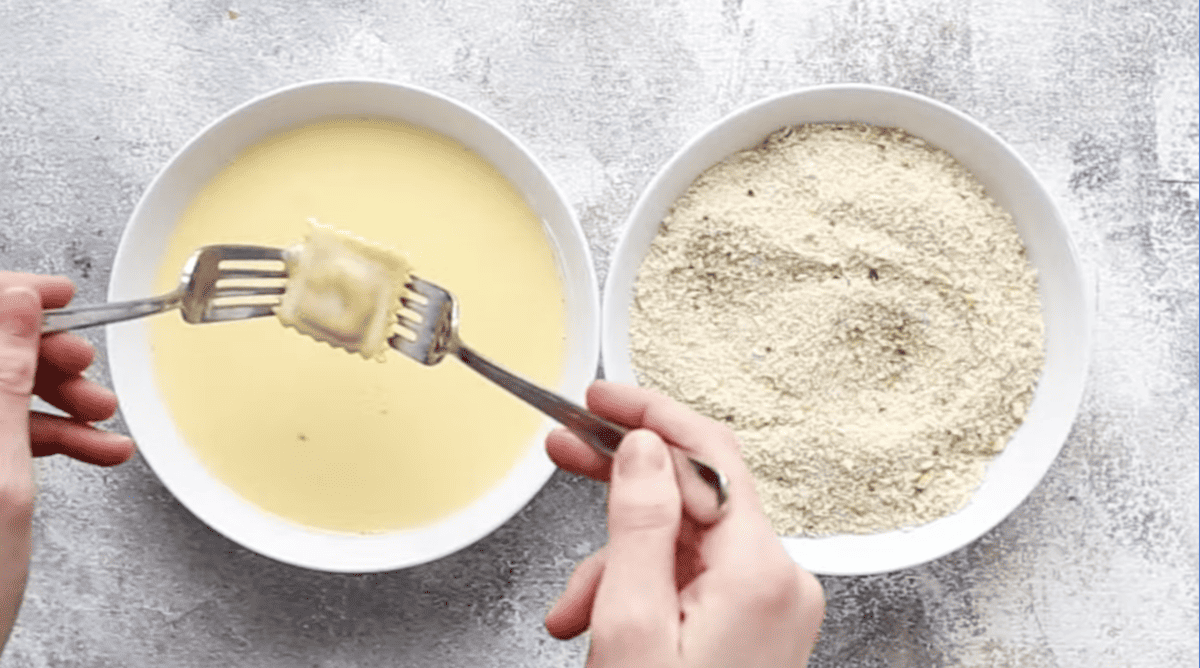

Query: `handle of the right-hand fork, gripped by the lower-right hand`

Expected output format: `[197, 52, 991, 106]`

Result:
[456, 343, 728, 524]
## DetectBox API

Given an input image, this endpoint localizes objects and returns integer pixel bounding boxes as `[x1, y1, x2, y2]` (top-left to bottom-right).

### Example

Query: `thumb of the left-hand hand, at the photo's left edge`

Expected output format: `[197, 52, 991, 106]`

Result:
[0, 288, 42, 448]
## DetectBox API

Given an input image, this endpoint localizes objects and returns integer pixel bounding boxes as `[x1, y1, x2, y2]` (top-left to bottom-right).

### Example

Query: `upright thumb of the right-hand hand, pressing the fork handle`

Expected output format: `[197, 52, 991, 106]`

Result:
[592, 429, 683, 666]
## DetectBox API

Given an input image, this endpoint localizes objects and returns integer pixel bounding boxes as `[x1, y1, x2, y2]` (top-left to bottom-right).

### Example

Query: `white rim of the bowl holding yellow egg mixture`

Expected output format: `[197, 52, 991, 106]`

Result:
[106, 78, 600, 573]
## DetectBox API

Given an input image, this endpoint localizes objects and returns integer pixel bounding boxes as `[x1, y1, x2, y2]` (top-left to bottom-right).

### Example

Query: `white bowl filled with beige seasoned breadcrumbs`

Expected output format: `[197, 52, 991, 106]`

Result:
[601, 85, 1091, 574]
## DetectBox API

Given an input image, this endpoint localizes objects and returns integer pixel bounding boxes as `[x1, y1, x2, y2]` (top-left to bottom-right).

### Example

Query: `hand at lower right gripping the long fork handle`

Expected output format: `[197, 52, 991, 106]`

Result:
[546, 381, 824, 668]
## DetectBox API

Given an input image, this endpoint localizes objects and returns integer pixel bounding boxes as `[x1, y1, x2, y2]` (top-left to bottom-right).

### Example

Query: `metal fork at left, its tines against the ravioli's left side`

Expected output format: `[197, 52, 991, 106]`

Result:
[42, 245, 288, 333]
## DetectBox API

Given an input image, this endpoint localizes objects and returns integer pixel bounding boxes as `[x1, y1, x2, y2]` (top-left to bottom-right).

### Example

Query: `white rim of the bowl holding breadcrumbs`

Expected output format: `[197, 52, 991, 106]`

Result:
[601, 83, 1093, 576]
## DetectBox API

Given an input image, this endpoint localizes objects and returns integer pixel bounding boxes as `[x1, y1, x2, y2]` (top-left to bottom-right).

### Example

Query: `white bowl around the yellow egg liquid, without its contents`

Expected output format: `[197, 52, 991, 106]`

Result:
[107, 80, 600, 572]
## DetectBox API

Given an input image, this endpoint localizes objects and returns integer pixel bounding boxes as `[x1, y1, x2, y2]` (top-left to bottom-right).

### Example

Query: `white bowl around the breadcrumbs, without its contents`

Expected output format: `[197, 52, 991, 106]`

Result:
[601, 85, 1091, 574]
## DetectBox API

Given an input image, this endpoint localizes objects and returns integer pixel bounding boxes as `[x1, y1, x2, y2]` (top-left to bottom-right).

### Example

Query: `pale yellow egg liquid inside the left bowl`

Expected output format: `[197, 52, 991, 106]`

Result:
[150, 120, 565, 532]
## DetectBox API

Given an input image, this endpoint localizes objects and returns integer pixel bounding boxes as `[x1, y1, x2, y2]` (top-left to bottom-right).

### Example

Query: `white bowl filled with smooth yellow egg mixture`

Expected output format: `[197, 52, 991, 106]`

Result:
[107, 80, 599, 572]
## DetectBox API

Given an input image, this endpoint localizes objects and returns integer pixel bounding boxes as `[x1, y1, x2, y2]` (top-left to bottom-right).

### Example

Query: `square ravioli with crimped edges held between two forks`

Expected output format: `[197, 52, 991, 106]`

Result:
[275, 222, 410, 360]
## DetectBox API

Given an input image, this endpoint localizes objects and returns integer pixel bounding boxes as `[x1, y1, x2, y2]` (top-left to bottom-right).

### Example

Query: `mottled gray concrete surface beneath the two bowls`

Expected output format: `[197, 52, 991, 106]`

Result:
[0, 0, 1198, 668]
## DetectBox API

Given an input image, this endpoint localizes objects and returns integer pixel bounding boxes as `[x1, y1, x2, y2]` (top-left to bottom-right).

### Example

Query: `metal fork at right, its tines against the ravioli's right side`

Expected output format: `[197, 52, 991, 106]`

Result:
[388, 276, 728, 524]
